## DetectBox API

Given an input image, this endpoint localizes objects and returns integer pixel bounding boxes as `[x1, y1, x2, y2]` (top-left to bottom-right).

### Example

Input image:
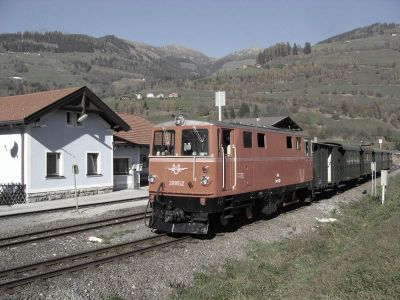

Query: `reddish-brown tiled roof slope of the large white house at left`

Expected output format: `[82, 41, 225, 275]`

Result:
[0, 87, 80, 122]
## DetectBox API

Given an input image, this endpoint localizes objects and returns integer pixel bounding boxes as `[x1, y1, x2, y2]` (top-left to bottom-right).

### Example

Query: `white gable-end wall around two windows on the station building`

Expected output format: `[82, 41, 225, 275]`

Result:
[25, 111, 113, 193]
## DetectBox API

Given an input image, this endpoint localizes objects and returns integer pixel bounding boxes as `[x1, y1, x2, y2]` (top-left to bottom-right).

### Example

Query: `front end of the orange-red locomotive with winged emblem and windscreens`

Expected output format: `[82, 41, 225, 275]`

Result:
[149, 121, 222, 233]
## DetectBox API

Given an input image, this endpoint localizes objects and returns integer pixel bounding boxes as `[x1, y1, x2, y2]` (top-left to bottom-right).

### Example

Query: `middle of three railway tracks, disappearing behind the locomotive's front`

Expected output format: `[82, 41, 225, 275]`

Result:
[0, 212, 151, 249]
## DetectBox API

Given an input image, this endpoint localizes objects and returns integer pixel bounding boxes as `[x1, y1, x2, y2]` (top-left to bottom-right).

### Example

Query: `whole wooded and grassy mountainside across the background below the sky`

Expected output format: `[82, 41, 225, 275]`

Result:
[0, 24, 400, 145]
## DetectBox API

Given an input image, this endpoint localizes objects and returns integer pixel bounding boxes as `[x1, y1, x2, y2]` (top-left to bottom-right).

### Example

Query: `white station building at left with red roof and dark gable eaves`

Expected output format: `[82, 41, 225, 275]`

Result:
[0, 87, 130, 202]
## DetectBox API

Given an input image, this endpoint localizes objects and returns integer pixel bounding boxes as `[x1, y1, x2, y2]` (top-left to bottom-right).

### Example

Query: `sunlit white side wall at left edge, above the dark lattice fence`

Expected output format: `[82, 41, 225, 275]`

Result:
[0, 129, 22, 184]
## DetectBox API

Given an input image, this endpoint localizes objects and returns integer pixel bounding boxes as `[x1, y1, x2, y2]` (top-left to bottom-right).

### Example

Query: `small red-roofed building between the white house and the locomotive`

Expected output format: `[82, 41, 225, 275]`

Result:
[114, 113, 154, 190]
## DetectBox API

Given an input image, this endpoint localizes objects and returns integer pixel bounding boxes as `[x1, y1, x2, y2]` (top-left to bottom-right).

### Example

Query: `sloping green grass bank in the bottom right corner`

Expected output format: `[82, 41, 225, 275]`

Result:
[173, 176, 400, 299]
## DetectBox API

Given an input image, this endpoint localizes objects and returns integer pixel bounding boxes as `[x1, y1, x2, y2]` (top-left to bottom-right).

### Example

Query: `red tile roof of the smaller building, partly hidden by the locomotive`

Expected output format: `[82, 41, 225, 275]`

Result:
[114, 113, 154, 145]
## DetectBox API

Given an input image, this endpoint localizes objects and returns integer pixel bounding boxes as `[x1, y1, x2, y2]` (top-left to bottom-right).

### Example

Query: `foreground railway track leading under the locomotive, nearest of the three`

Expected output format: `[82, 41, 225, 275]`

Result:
[0, 235, 191, 292]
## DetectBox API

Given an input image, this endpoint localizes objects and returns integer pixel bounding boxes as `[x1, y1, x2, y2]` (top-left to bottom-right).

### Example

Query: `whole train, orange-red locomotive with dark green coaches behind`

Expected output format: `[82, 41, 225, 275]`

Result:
[149, 116, 391, 234]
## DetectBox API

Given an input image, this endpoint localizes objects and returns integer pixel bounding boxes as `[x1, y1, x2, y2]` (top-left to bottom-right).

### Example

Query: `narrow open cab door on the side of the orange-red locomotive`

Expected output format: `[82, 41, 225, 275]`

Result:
[220, 129, 236, 191]
